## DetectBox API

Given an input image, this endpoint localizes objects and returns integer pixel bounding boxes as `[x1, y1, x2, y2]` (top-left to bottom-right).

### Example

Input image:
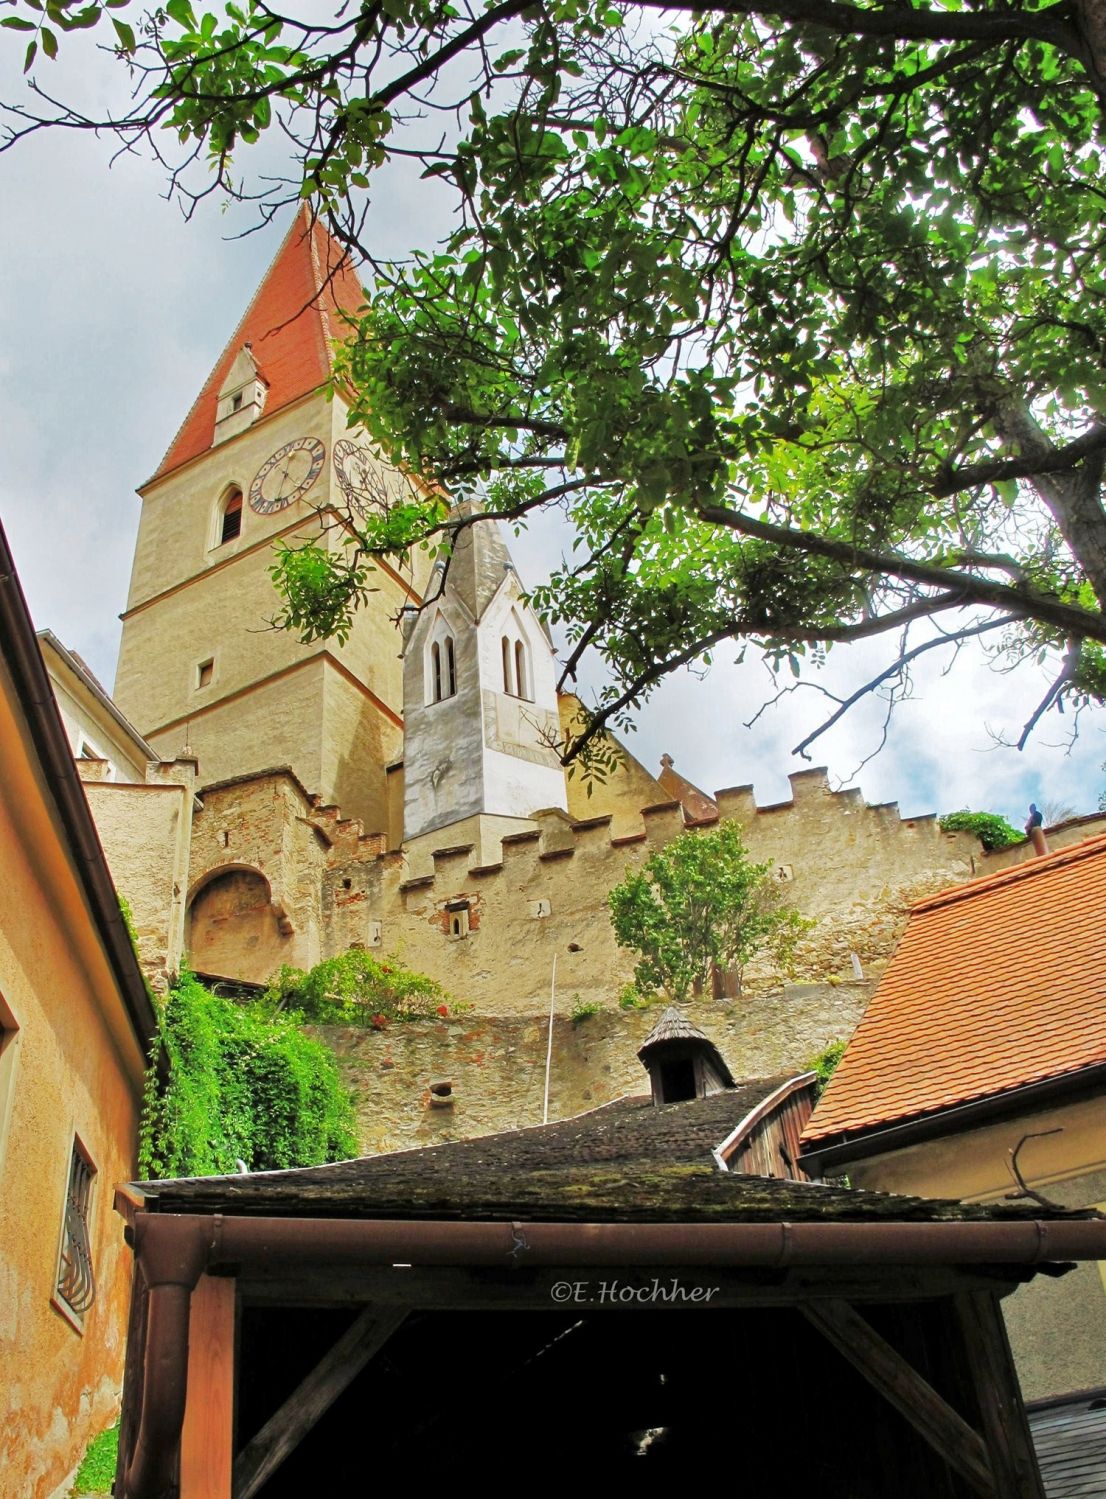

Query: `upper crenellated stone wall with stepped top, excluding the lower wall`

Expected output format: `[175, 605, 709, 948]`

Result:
[181, 755, 983, 1015]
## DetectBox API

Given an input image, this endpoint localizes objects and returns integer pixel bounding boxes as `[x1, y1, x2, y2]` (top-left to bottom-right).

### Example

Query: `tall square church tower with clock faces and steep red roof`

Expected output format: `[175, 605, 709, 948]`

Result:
[115, 207, 418, 832]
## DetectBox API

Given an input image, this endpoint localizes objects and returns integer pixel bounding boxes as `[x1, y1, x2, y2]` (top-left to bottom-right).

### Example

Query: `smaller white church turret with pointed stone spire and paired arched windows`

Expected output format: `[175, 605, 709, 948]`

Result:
[403, 502, 568, 862]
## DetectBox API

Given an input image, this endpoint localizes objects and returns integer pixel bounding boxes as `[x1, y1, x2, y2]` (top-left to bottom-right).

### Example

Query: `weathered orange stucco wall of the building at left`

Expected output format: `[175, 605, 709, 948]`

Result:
[0, 694, 144, 1499]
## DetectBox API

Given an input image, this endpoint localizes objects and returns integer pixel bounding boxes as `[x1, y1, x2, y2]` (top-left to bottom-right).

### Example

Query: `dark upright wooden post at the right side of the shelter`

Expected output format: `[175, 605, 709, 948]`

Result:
[953, 1292, 1045, 1499]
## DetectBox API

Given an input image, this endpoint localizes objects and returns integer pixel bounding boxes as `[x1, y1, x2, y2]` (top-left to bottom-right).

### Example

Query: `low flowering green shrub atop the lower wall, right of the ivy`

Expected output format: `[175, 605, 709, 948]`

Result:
[265, 947, 457, 1027]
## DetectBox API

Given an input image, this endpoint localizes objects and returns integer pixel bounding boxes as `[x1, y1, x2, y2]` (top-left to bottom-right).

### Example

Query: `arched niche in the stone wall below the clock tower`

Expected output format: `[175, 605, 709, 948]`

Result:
[186, 865, 292, 983]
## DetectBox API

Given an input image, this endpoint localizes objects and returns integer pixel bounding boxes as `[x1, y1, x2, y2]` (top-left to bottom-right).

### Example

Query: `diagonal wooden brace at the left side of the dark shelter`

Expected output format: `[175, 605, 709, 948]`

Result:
[232, 1307, 408, 1499]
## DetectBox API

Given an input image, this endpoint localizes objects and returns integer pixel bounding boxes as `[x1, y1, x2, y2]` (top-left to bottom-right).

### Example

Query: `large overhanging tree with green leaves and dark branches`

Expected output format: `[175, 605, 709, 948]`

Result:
[4, 0, 1106, 749]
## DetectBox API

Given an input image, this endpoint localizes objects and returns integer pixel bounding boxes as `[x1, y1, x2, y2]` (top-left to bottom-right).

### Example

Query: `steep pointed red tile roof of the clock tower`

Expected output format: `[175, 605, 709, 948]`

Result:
[153, 204, 364, 478]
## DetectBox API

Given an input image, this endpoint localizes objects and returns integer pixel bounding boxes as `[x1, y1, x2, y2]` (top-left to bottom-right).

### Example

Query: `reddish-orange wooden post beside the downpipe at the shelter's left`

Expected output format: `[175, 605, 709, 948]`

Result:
[180, 1276, 235, 1499]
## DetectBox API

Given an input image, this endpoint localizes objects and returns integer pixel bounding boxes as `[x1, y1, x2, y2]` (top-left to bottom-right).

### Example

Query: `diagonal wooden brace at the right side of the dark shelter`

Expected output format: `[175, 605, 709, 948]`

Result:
[800, 1300, 989, 1499]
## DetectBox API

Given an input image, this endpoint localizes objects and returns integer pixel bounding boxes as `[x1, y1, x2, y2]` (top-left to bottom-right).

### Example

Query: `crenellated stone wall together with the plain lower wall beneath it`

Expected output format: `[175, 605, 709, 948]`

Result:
[165, 755, 1106, 1151]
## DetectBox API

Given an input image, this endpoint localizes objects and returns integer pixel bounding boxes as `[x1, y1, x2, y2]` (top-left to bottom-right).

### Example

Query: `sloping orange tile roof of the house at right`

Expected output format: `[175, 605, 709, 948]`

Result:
[803, 836, 1106, 1145]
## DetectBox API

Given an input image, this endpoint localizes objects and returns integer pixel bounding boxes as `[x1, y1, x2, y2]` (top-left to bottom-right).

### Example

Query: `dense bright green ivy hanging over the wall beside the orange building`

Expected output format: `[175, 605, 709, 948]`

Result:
[138, 971, 357, 1177]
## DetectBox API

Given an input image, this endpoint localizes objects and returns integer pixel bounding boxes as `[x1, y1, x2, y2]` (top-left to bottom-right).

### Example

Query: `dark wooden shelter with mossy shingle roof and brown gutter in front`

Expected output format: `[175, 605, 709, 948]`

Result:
[115, 1100, 1106, 1499]
